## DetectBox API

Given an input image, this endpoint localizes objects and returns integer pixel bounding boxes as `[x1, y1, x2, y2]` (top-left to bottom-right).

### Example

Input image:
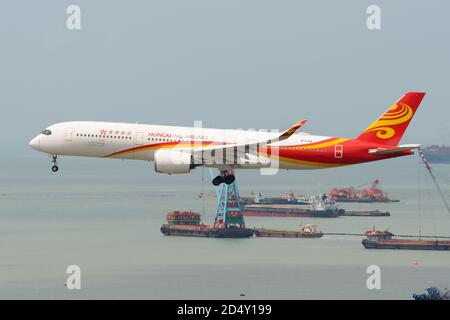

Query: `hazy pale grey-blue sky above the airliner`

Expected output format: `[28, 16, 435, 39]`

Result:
[0, 0, 450, 154]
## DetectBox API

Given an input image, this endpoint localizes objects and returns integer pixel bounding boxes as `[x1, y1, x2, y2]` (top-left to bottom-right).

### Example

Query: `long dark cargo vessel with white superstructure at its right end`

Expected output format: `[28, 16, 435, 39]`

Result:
[243, 197, 344, 218]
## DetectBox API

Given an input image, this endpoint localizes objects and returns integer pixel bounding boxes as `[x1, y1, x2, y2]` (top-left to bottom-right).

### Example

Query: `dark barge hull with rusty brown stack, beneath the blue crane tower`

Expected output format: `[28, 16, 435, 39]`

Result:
[161, 211, 255, 238]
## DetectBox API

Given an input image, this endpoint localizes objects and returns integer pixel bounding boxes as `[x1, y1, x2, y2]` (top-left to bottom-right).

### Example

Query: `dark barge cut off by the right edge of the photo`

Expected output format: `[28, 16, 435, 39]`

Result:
[362, 230, 450, 250]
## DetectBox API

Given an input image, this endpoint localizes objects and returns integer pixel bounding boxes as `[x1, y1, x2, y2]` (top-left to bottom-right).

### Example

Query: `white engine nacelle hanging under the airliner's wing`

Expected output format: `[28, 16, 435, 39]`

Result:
[155, 149, 195, 174]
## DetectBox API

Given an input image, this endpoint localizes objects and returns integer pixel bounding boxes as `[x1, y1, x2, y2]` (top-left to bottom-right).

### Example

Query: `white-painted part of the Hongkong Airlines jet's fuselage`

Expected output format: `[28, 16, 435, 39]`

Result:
[30, 121, 329, 169]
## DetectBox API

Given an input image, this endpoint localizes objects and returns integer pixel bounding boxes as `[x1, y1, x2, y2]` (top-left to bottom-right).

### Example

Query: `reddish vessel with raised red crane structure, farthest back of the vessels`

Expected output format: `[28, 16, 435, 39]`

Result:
[328, 180, 400, 203]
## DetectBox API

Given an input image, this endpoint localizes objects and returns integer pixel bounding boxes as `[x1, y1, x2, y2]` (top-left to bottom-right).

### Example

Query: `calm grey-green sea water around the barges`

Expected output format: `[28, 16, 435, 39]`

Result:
[0, 152, 450, 299]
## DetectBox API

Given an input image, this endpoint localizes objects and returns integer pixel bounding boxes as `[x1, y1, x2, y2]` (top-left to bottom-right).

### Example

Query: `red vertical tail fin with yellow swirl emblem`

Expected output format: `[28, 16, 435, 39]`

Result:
[356, 92, 425, 146]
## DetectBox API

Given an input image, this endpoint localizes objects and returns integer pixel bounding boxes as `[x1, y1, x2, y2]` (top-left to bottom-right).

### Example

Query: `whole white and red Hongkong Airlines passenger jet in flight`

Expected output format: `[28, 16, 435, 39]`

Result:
[30, 92, 425, 185]
